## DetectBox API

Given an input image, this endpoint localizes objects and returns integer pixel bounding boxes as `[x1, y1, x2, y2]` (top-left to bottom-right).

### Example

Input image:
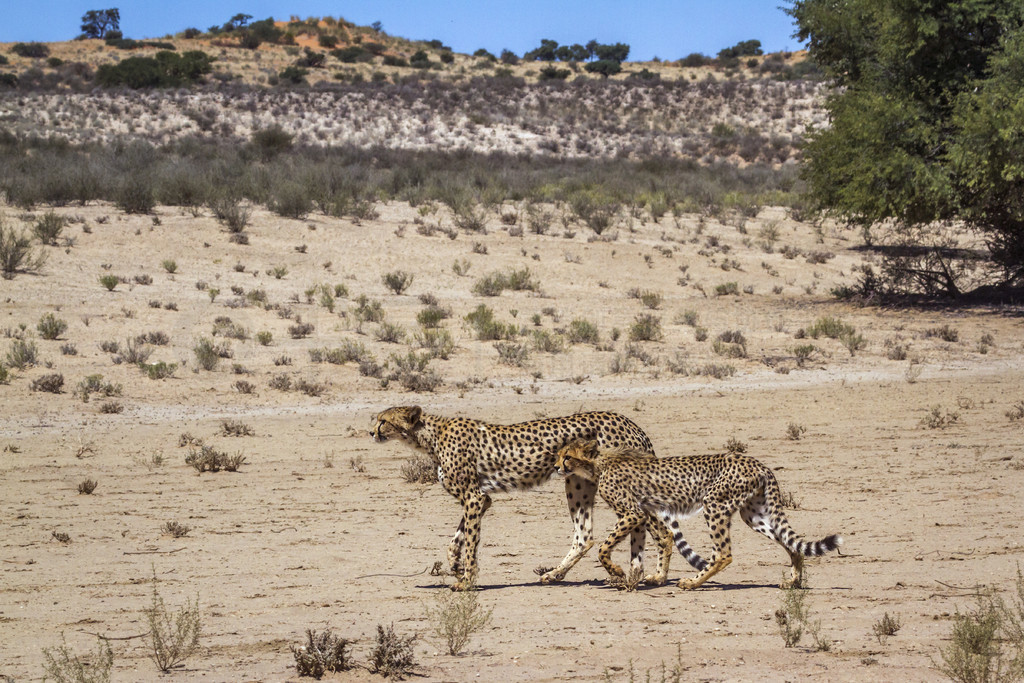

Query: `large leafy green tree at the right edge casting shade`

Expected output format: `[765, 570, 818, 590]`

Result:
[787, 0, 1024, 295]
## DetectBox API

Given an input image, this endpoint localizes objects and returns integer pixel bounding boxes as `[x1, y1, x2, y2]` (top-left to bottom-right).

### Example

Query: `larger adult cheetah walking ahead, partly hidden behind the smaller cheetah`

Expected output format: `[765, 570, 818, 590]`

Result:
[373, 405, 703, 590]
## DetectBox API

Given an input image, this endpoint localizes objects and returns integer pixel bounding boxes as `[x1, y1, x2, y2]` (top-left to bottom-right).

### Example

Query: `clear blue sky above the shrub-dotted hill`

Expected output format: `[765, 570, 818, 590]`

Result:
[0, 0, 800, 60]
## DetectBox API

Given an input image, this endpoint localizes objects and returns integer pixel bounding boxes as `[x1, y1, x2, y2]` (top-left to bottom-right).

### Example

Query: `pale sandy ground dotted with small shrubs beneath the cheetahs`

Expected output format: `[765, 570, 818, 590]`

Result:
[0, 200, 1024, 681]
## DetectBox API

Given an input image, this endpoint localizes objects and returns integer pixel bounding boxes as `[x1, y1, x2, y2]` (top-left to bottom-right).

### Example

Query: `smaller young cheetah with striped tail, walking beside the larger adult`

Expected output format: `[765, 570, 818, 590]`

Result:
[555, 440, 843, 589]
